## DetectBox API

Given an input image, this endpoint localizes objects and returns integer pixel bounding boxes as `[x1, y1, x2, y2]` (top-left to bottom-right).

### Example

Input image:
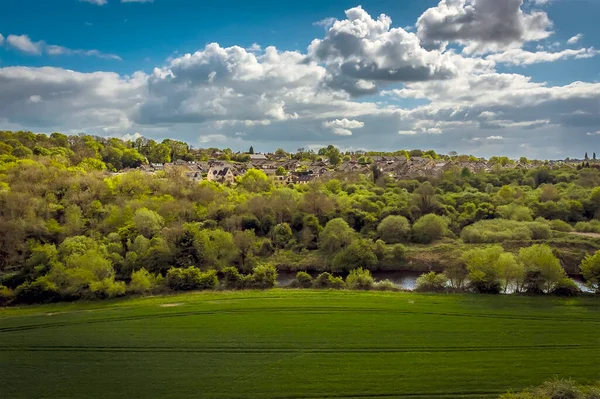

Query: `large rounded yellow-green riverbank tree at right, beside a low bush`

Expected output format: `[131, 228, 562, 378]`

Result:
[519, 244, 566, 293]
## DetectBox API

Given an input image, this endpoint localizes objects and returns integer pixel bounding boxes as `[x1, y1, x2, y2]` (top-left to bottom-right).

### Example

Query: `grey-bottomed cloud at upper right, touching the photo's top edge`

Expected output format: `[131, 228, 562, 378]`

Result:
[417, 0, 552, 54]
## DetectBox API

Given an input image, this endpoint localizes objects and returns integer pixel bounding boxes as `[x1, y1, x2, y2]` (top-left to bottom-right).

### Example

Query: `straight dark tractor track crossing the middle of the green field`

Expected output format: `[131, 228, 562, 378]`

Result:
[0, 344, 597, 355]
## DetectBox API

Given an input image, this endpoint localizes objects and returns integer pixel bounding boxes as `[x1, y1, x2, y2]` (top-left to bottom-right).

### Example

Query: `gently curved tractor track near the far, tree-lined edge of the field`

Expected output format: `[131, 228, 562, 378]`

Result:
[0, 307, 600, 333]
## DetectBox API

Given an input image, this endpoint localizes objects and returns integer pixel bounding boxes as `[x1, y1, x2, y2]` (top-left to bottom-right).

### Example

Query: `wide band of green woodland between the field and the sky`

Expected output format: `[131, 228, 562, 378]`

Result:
[0, 132, 600, 304]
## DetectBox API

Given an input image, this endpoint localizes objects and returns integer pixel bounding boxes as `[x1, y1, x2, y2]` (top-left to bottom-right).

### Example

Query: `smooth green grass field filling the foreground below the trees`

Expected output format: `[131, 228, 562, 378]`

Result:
[0, 290, 600, 399]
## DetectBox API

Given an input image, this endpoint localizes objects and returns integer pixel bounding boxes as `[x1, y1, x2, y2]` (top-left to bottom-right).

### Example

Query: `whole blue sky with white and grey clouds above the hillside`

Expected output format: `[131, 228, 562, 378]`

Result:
[0, 0, 600, 159]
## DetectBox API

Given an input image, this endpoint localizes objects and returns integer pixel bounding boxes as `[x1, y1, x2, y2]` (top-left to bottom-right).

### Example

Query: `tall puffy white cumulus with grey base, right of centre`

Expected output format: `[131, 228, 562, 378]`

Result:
[308, 6, 492, 95]
